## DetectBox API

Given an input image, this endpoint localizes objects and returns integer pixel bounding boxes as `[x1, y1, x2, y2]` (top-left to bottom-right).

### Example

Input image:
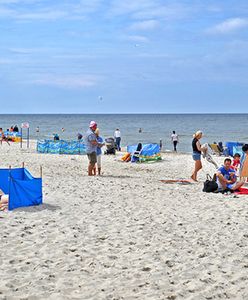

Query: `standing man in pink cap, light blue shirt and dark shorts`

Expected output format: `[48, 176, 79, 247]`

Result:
[84, 121, 98, 176]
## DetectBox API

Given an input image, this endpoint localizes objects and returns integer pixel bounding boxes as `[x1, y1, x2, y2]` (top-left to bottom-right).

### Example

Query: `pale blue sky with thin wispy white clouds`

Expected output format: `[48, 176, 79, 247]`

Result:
[0, 0, 248, 114]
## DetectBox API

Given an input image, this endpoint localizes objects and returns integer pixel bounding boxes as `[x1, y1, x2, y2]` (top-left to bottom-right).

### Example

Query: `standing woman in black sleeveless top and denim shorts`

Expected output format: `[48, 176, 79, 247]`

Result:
[191, 130, 206, 181]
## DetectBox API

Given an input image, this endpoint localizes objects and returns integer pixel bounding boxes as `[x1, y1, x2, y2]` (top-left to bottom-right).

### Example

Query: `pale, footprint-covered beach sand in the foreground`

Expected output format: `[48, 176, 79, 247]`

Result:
[0, 143, 248, 300]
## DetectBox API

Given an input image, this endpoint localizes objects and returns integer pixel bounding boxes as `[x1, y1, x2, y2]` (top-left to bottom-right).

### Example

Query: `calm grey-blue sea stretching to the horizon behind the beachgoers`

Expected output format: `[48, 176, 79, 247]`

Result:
[0, 114, 248, 152]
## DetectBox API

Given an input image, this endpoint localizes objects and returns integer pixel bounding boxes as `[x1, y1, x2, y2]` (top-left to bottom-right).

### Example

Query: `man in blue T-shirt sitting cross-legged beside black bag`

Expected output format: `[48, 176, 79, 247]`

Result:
[216, 158, 244, 191]
